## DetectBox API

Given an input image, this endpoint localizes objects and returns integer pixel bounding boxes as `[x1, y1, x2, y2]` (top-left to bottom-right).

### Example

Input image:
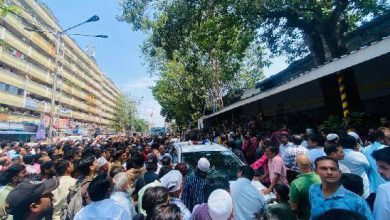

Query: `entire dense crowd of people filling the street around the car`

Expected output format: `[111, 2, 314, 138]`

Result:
[0, 117, 390, 220]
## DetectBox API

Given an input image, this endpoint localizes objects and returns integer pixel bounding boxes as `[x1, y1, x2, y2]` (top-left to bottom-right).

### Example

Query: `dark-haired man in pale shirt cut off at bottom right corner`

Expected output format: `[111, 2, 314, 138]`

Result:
[372, 147, 390, 220]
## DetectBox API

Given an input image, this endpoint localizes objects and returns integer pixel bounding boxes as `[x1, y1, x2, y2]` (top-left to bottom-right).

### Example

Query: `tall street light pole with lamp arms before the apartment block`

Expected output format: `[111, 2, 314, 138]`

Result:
[25, 15, 108, 141]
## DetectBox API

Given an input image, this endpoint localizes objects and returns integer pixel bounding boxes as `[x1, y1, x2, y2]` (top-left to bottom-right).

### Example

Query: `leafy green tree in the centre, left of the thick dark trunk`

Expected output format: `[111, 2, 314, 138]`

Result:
[119, 0, 264, 125]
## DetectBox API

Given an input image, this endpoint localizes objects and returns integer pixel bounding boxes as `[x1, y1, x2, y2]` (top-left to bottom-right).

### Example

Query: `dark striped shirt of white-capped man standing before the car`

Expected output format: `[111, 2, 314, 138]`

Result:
[181, 172, 207, 211]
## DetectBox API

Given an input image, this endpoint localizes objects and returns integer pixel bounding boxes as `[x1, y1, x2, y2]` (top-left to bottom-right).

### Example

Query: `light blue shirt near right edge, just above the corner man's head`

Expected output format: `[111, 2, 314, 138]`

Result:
[363, 142, 387, 193]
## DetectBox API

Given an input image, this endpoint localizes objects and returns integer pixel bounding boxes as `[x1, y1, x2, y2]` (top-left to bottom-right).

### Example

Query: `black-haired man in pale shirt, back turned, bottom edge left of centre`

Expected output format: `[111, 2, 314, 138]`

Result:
[74, 173, 131, 220]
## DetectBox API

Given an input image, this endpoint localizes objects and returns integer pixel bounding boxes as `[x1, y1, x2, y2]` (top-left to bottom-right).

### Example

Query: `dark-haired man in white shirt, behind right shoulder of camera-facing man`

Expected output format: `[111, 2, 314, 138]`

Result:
[339, 135, 370, 199]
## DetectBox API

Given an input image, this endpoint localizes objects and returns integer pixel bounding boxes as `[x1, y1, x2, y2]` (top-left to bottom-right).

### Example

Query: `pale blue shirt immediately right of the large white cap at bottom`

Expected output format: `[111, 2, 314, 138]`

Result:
[230, 178, 265, 220]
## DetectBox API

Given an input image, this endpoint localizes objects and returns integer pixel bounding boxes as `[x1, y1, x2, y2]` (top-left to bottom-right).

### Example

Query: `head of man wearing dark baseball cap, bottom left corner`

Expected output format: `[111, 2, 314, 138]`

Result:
[7, 178, 59, 220]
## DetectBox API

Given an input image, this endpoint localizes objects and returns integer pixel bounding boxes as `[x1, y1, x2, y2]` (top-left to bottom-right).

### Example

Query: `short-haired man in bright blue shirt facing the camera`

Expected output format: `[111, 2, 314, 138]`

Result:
[309, 156, 374, 220]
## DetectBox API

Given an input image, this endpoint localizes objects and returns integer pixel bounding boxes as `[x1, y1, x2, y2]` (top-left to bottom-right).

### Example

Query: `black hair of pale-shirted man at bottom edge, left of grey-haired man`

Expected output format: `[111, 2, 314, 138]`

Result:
[87, 173, 110, 202]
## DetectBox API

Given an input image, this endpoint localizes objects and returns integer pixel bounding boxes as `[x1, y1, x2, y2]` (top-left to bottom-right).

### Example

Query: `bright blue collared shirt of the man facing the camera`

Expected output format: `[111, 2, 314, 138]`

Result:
[309, 184, 374, 220]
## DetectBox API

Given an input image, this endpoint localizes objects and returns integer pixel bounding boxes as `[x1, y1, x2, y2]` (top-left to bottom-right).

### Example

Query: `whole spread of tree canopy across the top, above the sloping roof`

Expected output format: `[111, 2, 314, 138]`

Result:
[118, 0, 390, 124]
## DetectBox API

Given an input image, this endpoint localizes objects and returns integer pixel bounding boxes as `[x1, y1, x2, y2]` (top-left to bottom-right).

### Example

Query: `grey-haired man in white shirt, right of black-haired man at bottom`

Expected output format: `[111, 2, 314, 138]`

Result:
[110, 172, 137, 218]
